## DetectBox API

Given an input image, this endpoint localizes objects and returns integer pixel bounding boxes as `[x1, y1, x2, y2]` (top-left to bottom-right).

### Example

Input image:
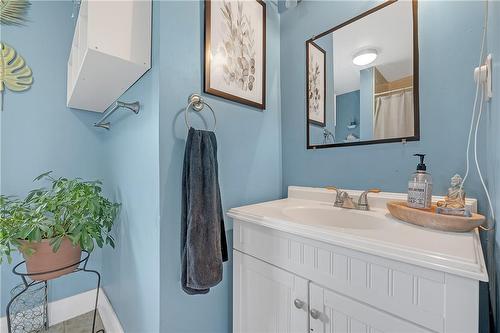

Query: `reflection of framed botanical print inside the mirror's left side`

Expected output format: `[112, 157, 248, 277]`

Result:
[306, 41, 326, 127]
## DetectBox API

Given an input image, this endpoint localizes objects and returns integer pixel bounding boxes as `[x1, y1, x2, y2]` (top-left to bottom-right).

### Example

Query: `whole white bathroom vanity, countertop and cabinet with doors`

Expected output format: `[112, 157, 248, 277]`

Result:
[229, 187, 487, 333]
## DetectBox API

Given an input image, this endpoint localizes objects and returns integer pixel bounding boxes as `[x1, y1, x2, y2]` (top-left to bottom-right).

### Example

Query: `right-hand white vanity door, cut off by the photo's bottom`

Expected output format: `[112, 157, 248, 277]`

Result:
[309, 283, 431, 333]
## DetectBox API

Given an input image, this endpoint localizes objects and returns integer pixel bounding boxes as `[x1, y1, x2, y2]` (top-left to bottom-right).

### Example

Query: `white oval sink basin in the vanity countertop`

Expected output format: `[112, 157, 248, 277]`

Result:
[283, 206, 383, 229]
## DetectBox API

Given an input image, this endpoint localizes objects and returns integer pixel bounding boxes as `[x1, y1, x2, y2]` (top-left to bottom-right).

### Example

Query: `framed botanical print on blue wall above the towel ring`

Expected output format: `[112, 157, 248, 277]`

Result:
[204, 0, 266, 109]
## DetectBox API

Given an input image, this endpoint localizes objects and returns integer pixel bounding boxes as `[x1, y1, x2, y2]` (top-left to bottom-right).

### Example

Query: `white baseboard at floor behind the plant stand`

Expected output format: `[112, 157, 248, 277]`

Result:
[0, 288, 123, 333]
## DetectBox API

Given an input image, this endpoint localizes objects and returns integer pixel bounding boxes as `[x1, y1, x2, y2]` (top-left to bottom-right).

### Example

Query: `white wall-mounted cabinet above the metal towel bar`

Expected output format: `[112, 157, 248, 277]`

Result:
[67, 0, 152, 112]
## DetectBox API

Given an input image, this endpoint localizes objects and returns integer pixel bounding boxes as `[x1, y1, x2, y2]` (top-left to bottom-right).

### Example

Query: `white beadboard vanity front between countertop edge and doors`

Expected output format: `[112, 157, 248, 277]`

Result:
[234, 220, 479, 333]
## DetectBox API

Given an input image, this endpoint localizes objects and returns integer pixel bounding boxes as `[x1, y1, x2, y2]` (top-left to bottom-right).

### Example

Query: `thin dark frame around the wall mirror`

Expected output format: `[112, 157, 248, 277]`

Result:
[305, 0, 420, 149]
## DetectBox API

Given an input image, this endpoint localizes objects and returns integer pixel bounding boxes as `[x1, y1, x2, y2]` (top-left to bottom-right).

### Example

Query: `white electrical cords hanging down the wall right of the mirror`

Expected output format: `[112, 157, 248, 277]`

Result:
[460, 0, 495, 230]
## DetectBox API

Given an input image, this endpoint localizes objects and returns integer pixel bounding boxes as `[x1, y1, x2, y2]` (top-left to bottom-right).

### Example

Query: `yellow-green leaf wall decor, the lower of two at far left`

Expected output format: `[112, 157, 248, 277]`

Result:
[0, 43, 33, 110]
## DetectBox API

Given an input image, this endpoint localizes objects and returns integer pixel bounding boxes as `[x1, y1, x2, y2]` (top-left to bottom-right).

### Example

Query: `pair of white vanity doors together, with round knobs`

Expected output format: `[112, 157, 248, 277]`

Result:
[233, 251, 431, 333]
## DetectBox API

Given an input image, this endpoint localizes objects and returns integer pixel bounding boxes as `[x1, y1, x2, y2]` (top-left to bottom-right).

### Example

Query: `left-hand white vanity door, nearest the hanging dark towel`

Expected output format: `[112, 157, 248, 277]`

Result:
[233, 250, 308, 333]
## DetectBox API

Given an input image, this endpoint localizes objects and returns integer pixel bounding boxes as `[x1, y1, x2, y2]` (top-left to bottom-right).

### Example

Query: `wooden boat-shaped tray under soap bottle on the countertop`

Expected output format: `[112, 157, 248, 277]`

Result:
[387, 201, 485, 232]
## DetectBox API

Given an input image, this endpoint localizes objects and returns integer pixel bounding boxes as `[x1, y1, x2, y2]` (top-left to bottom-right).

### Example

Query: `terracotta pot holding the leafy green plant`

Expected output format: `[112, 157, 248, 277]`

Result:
[21, 238, 82, 281]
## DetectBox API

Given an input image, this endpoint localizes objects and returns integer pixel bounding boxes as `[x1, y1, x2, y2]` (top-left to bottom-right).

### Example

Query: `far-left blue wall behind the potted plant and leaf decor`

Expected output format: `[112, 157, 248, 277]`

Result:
[0, 1, 105, 314]
